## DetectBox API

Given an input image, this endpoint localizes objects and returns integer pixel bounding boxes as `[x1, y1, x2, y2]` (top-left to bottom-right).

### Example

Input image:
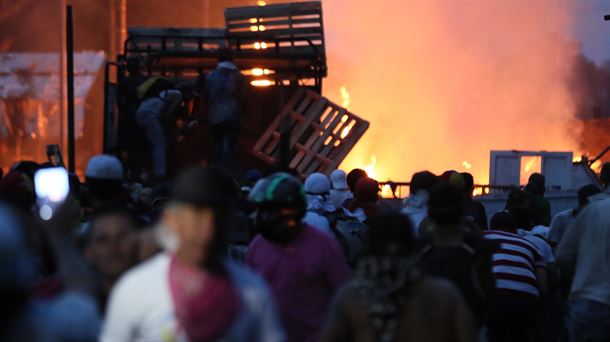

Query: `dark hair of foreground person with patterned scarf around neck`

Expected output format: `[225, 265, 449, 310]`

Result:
[367, 210, 414, 255]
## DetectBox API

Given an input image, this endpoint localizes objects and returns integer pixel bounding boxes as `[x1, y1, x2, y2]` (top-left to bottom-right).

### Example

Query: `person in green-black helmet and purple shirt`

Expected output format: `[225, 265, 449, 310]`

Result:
[246, 173, 349, 342]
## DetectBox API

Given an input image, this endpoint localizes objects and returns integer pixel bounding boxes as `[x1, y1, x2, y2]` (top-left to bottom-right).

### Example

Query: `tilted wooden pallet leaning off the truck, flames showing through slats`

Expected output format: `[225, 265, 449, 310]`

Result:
[252, 88, 369, 178]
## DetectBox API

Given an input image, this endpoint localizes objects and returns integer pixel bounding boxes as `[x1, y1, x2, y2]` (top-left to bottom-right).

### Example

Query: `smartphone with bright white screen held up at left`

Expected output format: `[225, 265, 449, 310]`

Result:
[34, 167, 70, 220]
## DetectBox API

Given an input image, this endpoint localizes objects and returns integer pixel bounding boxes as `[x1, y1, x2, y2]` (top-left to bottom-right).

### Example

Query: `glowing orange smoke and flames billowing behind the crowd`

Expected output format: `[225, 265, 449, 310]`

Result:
[324, 0, 579, 183]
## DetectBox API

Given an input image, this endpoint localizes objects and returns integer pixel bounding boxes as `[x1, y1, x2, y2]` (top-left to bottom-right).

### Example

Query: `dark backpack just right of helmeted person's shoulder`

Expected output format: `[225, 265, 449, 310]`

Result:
[316, 209, 368, 265]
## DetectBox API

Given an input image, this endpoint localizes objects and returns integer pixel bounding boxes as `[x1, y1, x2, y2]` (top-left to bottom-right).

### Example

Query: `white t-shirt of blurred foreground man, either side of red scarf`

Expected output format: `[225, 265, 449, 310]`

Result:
[100, 253, 285, 342]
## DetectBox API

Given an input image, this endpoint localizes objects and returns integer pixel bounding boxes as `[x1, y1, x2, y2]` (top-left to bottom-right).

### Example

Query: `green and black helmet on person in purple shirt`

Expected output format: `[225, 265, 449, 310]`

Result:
[248, 172, 307, 214]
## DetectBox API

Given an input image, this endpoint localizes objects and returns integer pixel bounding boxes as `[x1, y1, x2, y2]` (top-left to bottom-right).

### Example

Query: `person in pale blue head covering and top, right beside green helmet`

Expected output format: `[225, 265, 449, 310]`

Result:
[303, 172, 336, 235]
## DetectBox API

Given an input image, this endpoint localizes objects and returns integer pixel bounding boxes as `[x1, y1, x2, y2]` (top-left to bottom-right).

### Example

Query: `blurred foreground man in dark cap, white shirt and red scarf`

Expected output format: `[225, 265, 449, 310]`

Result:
[101, 167, 284, 341]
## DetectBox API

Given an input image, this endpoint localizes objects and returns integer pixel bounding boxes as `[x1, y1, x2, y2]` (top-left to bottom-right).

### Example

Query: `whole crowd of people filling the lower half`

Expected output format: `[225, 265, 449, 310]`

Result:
[0, 151, 610, 342]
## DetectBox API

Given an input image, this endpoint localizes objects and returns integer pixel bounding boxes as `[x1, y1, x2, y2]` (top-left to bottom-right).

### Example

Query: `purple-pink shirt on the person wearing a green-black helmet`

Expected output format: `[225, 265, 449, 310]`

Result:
[246, 226, 350, 341]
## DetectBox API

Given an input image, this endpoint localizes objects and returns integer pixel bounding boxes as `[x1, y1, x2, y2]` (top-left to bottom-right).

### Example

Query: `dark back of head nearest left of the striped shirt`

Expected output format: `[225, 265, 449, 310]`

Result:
[428, 183, 465, 226]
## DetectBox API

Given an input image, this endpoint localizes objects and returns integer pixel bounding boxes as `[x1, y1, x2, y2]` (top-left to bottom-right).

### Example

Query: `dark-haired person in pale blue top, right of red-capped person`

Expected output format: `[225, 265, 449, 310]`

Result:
[401, 171, 438, 237]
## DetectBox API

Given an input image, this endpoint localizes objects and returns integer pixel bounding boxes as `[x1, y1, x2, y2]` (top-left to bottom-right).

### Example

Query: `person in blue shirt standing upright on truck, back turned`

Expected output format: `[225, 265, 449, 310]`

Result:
[203, 49, 248, 163]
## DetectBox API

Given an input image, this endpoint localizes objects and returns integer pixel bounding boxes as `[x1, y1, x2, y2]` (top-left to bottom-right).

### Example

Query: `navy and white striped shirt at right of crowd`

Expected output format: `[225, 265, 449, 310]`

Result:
[483, 230, 546, 298]
